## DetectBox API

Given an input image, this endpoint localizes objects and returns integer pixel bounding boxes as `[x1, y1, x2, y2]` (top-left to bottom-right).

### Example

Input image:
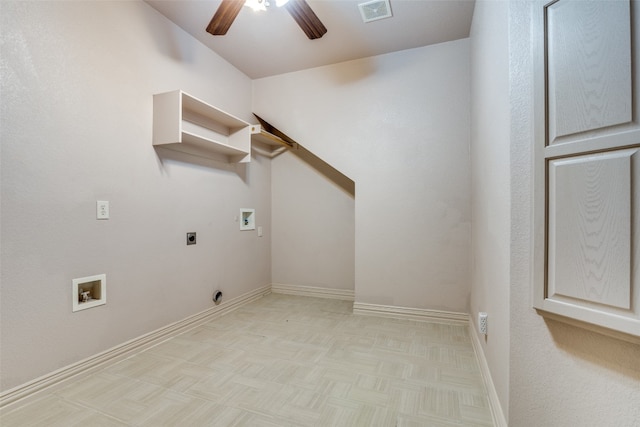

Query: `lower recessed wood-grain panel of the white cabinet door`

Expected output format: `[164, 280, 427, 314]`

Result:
[548, 150, 640, 310]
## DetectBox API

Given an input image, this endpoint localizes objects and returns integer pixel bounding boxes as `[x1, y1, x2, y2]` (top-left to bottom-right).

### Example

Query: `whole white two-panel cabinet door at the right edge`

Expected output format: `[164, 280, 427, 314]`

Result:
[534, 0, 640, 341]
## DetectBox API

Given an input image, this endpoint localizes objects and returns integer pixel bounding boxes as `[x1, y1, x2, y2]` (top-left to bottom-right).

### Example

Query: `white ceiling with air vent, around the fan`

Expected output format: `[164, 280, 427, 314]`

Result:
[146, 0, 474, 79]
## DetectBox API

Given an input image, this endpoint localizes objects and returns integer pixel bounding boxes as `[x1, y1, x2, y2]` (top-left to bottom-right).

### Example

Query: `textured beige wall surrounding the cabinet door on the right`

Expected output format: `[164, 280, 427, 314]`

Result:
[502, 1, 640, 427]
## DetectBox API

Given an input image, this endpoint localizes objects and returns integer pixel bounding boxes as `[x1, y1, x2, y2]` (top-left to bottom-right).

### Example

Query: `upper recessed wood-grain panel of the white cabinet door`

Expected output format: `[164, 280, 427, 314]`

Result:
[546, 1, 632, 144]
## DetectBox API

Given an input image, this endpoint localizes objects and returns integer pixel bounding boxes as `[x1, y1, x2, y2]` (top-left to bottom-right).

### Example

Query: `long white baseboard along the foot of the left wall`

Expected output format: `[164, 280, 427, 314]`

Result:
[0, 285, 271, 409]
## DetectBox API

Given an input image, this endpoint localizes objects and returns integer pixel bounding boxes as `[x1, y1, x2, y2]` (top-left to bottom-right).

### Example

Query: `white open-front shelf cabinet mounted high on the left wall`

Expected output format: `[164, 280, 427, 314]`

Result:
[153, 90, 251, 163]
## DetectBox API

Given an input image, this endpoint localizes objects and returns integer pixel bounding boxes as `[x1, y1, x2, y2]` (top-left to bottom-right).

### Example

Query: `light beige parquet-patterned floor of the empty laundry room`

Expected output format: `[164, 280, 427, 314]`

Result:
[1, 295, 492, 427]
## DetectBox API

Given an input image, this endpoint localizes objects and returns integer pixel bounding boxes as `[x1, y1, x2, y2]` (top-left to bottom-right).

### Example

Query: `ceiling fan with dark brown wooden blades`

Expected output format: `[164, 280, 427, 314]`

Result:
[207, 0, 327, 40]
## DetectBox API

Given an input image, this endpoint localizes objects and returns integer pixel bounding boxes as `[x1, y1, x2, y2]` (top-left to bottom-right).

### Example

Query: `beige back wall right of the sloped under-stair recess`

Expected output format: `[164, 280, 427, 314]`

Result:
[253, 40, 470, 311]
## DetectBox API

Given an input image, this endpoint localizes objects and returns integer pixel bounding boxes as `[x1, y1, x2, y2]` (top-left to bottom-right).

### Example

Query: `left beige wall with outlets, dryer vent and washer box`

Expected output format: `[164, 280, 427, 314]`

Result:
[0, 1, 271, 390]
